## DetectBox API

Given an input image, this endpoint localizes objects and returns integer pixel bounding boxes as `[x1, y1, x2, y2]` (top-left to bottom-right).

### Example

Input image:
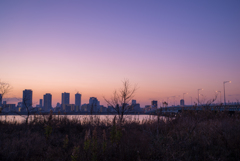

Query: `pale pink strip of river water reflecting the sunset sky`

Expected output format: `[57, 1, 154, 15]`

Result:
[0, 115, 165, 123]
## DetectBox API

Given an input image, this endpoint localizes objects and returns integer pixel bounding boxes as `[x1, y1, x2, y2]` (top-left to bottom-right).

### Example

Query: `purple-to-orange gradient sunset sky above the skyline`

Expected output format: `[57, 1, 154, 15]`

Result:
[0, 0, 240, 107]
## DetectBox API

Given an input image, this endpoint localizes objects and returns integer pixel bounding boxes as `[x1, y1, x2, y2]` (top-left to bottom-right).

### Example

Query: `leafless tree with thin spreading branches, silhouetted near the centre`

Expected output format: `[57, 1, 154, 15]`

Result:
[104, 80, 137, 123]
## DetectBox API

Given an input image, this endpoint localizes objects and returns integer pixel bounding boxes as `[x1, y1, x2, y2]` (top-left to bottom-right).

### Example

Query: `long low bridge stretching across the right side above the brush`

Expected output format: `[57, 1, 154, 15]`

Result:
[145, 104, 240, 115]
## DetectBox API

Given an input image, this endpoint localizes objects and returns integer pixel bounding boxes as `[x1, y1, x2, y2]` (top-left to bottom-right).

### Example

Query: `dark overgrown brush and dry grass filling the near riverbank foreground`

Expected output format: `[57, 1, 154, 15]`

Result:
[0, 110, 240, 161]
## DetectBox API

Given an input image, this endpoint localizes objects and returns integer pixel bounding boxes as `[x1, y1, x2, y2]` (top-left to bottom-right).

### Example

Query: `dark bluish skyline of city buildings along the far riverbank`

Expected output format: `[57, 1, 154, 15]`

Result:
[0, 89, 150, 113]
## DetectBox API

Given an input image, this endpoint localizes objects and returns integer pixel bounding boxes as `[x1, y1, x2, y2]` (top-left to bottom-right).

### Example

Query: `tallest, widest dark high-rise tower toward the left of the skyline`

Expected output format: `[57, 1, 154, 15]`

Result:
[22, 89, 32, 111]
